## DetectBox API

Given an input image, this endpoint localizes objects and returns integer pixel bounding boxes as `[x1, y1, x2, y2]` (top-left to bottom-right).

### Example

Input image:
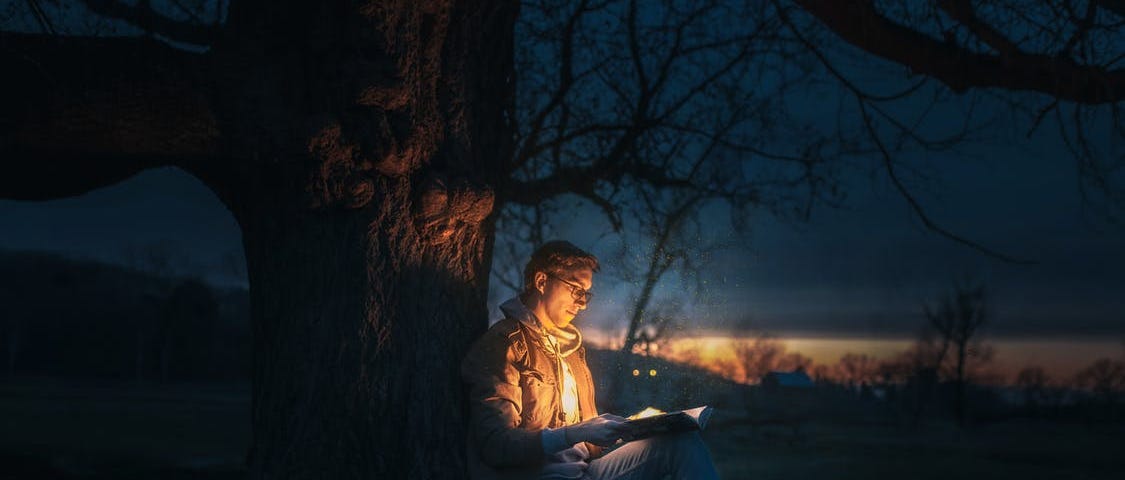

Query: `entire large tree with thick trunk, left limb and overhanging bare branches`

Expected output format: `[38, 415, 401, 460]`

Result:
[0, 0, 1125, 478]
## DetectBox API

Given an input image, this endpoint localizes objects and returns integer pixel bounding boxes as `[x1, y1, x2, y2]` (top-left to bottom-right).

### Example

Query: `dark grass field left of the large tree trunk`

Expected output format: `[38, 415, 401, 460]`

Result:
[0, 381, 250, 478]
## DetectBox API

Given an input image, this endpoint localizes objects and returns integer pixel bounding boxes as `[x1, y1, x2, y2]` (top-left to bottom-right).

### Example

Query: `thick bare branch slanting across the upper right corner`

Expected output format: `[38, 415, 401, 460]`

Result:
[794, 0, 1125, 105]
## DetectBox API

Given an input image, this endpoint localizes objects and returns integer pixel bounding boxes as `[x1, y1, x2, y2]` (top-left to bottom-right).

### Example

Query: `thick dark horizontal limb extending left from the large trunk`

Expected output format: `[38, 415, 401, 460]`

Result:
[0, 34, 218, 200]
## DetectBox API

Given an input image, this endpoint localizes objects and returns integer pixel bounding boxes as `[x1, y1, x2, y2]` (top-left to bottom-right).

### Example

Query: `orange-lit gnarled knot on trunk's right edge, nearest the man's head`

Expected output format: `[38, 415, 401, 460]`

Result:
[414, 180, 495, 244]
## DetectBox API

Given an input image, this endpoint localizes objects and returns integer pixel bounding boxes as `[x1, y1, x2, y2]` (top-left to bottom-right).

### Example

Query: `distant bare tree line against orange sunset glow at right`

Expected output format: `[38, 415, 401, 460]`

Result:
[657, 281, 1125, 427]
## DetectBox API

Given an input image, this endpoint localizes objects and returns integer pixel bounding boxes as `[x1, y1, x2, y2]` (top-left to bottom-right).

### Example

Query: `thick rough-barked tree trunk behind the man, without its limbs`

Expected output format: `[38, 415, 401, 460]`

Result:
[212, 1, 515, 479]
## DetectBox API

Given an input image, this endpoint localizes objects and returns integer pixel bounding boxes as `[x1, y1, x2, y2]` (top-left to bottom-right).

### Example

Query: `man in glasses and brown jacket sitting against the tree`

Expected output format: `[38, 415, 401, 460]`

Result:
[461, 241, 718, 480]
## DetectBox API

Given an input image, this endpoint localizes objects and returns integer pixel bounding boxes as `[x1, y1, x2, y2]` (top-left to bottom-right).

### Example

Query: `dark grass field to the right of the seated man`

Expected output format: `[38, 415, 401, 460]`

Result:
[704, 413, 1125, 479]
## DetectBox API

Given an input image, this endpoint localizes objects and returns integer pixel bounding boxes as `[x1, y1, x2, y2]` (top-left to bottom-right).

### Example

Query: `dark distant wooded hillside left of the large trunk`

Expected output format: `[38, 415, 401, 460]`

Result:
[0, 252, 251, 381]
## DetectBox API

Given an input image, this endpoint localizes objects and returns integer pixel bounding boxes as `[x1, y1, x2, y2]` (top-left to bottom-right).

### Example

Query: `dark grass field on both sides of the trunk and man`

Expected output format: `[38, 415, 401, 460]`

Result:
[0, 380, 1125, 479]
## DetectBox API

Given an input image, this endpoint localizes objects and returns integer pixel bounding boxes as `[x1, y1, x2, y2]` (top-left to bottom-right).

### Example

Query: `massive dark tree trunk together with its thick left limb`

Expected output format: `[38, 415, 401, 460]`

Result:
[0, 0, 518, 479]
